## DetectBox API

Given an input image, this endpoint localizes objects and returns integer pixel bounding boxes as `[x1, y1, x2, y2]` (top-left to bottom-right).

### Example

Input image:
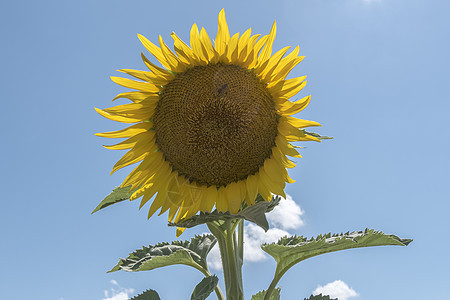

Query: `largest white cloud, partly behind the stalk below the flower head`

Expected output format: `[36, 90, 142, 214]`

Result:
[207, 195, 304, 270]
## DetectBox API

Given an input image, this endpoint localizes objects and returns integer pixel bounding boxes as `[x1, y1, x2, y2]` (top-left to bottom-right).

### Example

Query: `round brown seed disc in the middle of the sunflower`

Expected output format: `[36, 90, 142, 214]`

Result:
[153, 64, 278, 186]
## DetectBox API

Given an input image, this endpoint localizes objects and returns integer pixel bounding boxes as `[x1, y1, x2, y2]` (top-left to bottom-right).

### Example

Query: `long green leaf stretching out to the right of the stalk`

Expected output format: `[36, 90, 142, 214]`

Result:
[261, 229, 412, 279]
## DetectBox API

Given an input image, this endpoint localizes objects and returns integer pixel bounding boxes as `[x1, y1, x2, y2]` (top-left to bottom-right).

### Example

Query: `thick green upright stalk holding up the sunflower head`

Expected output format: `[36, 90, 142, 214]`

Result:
[207, 220, 244, 300]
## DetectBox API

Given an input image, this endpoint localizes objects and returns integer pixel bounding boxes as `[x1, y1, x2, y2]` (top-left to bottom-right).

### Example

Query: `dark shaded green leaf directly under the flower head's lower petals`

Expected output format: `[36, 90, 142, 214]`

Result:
[169, 195, 281, 231]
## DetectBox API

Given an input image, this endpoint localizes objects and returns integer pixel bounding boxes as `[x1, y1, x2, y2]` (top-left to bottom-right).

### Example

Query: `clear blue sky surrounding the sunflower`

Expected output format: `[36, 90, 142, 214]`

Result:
[0, 0, 450, 300]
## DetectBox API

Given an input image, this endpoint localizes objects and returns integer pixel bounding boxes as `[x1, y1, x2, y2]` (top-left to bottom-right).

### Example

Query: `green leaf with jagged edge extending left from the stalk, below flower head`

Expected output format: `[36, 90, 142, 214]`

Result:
[108, 234, 217, 273]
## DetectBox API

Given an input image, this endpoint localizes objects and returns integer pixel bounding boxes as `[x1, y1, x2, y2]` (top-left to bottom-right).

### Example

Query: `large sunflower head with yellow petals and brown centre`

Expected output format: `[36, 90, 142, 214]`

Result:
[96, 10, 320, 230]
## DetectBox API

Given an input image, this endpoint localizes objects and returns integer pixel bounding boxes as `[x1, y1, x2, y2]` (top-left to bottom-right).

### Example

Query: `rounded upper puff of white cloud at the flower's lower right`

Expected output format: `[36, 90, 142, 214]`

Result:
[267, 195, 304, 230]
